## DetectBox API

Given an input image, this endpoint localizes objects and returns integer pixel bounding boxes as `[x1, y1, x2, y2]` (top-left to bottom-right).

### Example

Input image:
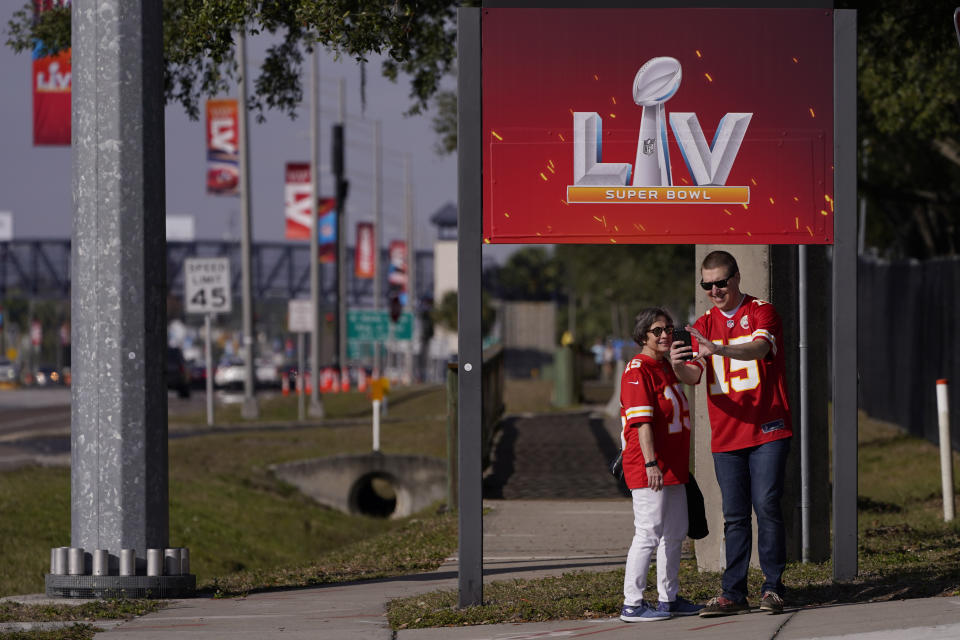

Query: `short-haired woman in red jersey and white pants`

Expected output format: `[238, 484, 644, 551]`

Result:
[620, 307, 703, 622]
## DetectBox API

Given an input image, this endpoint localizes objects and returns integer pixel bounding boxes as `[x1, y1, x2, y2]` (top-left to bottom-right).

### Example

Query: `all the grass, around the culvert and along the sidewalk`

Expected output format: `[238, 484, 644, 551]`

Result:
[9, 381, 960, 640]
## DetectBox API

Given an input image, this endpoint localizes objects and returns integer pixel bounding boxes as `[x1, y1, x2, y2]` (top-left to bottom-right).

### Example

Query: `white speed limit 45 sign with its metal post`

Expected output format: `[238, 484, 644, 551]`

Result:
[183, 258, 233, 426]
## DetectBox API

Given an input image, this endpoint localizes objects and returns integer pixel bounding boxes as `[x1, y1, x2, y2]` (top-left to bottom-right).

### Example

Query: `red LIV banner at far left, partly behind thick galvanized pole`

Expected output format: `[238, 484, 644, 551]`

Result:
[33, 0, 72, 146]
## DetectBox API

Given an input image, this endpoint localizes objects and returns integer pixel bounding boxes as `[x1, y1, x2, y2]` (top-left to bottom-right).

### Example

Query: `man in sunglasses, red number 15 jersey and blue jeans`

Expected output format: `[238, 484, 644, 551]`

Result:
[670, 251, 793, 617]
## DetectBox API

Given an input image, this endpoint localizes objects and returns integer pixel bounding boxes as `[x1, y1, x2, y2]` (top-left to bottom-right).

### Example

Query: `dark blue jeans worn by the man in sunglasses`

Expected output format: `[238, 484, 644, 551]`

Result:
[713, 438, 791, 602]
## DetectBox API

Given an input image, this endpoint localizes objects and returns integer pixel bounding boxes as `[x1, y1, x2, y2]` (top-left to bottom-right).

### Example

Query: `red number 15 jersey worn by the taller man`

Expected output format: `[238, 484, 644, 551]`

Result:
[693, 295, 793, 452]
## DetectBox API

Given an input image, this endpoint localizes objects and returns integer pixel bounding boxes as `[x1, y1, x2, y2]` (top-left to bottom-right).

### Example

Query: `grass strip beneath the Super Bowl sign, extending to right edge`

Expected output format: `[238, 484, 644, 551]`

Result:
[387, 416, 960, 629]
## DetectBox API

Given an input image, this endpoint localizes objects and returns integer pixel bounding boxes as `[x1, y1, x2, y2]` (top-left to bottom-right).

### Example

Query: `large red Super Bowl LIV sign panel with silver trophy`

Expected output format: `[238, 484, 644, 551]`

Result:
[481, 8, 834, 244]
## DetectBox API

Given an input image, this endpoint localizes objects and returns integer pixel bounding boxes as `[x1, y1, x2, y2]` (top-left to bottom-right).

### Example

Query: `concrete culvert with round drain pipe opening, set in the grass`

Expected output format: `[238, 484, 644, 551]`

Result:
[269, 453, 447, 518]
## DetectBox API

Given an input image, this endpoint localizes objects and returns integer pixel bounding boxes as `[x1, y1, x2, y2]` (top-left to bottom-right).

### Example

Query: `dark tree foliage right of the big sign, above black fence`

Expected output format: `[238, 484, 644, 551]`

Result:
[844, 0, 960, 258]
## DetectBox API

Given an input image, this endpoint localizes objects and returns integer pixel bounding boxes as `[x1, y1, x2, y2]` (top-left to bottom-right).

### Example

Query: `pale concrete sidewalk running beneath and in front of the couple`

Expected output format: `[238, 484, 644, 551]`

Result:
[7, 500, 960, 640]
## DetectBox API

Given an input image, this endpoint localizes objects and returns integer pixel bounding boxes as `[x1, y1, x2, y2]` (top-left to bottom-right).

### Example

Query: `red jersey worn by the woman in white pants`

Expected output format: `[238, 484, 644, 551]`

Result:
[620, 354, 690, 489]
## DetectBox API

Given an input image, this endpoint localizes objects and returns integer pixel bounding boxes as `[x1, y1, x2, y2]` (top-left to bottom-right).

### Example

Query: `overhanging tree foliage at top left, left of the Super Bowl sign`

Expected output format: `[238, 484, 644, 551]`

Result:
[7, 0, 456, 119]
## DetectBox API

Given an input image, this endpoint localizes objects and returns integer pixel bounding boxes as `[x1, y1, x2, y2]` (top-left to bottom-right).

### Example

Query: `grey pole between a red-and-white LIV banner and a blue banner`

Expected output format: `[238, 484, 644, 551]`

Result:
[312, 49, 324, 418]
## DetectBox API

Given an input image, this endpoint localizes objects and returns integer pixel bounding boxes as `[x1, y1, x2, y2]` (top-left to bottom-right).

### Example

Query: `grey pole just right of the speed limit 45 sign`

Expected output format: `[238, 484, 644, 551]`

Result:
[237, 29, 260, 420]
